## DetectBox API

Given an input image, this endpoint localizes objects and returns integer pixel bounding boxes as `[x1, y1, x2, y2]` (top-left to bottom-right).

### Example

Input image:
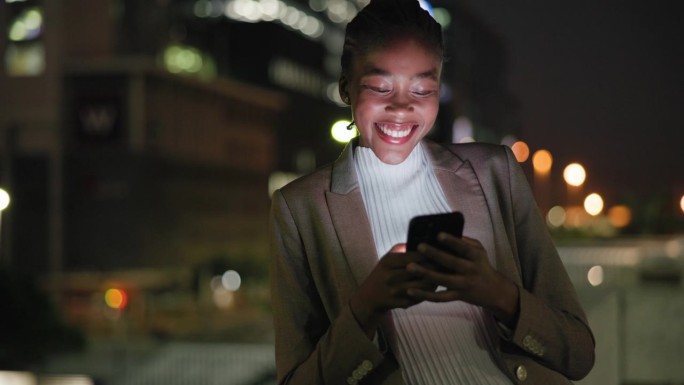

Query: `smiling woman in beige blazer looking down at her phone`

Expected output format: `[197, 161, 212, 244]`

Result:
[271, 0, 594, 385]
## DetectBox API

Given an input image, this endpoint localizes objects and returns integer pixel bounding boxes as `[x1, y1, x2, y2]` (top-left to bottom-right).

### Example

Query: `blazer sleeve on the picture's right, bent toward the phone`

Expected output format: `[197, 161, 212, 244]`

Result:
[496, 147, 595, 380]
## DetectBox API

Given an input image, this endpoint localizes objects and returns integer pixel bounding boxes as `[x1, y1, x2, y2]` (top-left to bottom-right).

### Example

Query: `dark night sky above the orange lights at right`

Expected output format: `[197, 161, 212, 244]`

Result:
[464, 0, 684, 204]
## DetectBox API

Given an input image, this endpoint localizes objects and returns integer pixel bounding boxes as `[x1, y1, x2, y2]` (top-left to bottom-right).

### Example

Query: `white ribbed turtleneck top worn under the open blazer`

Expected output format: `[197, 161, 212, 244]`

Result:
[354, 144, 511, 385]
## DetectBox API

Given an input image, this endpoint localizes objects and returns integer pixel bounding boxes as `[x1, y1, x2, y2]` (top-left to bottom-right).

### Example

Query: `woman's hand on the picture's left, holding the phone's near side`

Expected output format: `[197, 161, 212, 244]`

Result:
[350, 244, 435, 338]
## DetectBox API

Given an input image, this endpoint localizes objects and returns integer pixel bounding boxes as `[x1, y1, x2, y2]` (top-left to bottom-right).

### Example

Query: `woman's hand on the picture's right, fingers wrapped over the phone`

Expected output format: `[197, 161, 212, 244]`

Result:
[406, 233, 518, 326]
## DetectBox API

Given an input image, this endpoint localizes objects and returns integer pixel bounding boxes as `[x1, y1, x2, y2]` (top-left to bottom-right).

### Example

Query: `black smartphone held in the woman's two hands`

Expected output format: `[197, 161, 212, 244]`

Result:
[406, 211, 464, 251]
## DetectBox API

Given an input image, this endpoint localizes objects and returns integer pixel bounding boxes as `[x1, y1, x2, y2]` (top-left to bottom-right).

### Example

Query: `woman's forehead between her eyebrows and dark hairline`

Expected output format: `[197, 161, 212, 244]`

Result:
[352, 39, 442, 77]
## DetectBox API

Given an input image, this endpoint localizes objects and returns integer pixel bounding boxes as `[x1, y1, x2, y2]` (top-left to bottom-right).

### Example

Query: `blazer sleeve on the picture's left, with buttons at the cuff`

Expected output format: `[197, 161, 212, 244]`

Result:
[270, 191, 384, 385]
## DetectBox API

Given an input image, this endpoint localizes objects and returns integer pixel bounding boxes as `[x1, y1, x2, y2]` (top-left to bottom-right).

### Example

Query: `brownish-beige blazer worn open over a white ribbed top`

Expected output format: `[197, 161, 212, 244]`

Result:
[271, 141, 594, 385]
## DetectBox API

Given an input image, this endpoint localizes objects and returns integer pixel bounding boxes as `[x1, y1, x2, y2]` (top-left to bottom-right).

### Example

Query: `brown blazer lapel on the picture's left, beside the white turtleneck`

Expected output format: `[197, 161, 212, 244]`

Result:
[325, 142, 378, 285]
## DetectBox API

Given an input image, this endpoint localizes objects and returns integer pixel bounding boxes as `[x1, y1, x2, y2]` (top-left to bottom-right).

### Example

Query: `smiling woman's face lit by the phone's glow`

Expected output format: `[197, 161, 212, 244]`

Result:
[340, 39, 442, 164]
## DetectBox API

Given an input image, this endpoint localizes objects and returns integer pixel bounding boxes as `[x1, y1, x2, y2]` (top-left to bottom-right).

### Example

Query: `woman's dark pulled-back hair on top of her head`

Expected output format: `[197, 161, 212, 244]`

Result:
[341, 0, 444, 76]
